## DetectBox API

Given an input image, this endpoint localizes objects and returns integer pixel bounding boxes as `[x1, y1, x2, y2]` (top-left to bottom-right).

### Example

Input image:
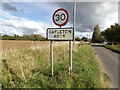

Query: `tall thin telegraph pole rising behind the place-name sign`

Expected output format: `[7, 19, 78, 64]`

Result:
[73, 0, 76, 51]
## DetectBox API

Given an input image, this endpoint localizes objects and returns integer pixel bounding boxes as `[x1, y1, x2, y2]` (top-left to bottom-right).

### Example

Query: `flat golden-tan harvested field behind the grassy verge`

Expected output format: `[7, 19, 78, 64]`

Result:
[0, 40, 68, 51]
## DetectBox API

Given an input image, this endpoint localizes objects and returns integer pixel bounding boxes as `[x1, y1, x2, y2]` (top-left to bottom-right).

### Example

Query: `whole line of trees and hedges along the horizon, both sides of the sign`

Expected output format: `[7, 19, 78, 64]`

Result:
[0, 23, 120, 44]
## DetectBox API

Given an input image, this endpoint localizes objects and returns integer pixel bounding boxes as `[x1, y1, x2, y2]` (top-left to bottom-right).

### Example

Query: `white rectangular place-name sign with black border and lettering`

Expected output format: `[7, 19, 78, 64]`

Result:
[47, 28, 74, 40]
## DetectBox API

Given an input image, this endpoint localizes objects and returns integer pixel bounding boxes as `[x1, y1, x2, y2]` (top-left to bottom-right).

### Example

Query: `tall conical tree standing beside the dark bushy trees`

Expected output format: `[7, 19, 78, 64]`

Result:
[92, 25, 103, 43]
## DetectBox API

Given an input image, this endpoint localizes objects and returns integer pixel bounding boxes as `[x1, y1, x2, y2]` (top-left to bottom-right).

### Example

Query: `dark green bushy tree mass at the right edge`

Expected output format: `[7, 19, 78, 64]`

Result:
[102, 24, 120, 44]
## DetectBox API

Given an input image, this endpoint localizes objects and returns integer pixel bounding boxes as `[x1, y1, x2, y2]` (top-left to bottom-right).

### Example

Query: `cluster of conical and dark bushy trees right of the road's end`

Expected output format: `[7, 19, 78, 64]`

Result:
[92, 23, 120, 44]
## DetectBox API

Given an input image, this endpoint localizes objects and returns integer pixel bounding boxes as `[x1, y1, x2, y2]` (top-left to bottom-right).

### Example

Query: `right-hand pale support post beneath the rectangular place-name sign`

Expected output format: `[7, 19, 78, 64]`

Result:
[69, 41, 72, 77]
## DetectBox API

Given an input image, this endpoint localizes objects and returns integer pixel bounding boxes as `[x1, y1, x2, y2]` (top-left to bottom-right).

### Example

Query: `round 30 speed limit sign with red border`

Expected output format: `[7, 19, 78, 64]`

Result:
[53, 9, 69, 26]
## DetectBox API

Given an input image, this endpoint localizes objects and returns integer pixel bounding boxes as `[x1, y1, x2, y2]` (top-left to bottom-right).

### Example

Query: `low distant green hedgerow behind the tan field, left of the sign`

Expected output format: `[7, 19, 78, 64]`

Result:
[2, 34, 45, 41]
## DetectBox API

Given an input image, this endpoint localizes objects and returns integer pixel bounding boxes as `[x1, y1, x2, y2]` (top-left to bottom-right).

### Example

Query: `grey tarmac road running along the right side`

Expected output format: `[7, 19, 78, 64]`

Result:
[92, 45, 118, 88]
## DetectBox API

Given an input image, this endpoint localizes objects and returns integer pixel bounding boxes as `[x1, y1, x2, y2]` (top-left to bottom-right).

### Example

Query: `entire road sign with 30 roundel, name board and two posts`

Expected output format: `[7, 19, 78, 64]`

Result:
[47, 8, 74, 76]
